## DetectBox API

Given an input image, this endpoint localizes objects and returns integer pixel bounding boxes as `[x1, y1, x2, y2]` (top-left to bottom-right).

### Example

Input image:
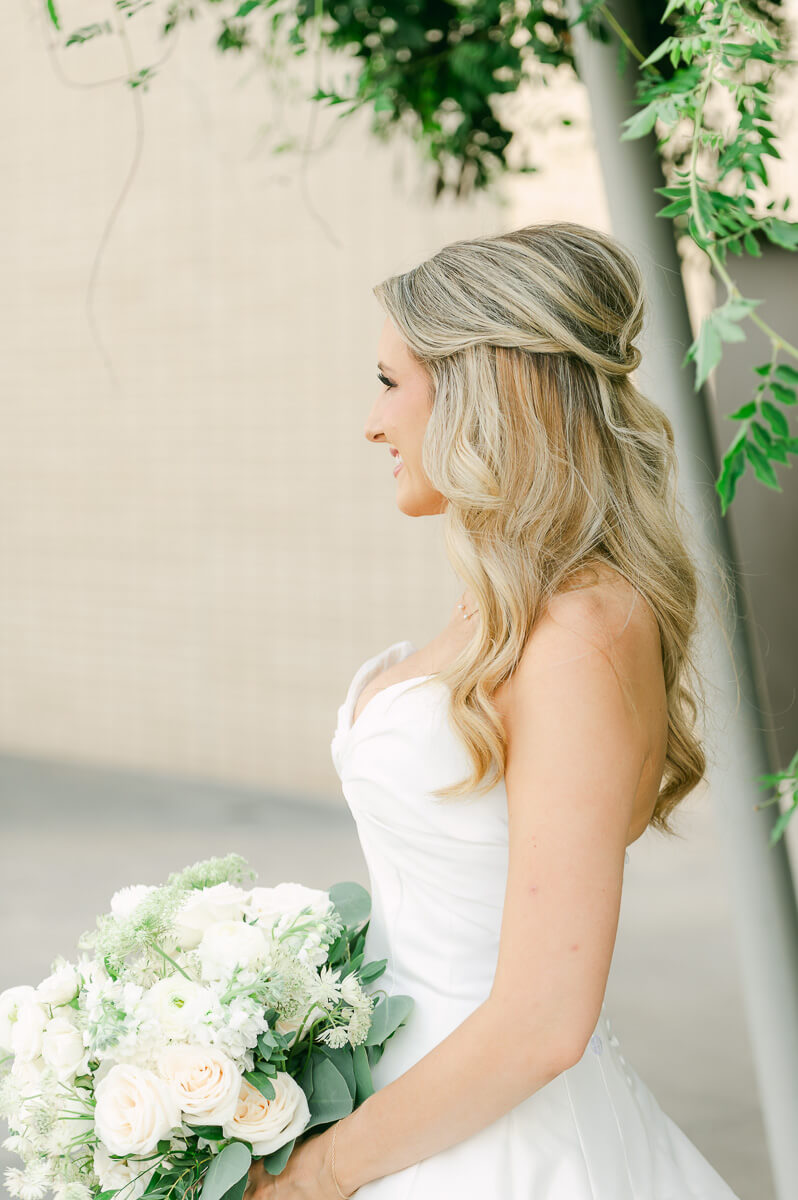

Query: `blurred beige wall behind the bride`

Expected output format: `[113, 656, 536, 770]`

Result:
[0, 4, 794, 796]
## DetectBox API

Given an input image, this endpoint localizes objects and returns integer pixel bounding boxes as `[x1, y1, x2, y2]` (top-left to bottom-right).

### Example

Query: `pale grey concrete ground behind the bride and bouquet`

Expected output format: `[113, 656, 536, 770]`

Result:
[0, 756, 775, 1200]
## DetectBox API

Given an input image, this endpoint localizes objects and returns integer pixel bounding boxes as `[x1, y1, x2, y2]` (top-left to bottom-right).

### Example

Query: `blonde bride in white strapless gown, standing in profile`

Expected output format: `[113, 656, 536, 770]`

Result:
[245, 222, 737, 1200]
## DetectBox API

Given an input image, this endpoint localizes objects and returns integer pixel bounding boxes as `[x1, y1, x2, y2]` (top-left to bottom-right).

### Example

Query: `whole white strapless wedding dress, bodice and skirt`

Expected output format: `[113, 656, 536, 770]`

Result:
[330, 641, 739, 1200]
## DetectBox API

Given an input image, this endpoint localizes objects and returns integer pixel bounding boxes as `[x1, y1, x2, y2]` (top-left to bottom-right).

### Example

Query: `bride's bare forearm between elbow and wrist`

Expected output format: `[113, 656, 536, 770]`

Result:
[335, 998, 572, 1195]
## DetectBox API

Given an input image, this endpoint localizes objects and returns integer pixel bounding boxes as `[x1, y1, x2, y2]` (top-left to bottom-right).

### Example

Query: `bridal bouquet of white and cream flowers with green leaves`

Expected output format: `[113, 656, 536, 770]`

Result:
[0, 854, 413, 1200]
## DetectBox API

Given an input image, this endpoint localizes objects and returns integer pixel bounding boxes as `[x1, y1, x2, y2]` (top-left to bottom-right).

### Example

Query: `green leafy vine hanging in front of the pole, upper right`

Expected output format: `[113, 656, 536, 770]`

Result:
[622, 0, 798, 532]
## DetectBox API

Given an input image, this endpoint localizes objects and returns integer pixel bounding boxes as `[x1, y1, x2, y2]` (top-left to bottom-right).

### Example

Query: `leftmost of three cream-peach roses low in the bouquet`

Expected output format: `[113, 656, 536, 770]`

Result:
[95, 1063, 180, 1156]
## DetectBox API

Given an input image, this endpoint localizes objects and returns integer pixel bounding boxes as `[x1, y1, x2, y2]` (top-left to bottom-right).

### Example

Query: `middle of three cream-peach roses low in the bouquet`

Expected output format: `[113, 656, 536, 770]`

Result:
[157, 1045, 241, 1126]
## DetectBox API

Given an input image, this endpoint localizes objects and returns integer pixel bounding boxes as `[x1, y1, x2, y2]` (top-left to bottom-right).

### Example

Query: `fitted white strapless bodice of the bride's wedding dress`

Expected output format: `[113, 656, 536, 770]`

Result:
[331, 641, 508, 1046]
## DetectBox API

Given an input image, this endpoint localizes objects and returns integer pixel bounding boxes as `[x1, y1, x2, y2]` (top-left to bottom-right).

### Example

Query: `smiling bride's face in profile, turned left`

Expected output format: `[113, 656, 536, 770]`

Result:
[365, 317, 445, 517]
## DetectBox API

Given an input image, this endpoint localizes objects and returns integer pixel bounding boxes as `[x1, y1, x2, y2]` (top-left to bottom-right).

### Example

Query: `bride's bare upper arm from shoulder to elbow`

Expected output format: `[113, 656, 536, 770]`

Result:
[490, 593, 650, 1073]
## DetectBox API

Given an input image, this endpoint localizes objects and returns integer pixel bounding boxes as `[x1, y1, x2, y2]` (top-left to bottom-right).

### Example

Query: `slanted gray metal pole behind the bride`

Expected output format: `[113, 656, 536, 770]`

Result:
[566, 0, 798, 1200]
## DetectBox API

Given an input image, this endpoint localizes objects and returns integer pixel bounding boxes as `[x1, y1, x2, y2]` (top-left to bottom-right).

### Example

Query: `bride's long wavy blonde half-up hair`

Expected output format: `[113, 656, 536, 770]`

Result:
[373, 221, 724, 834]
